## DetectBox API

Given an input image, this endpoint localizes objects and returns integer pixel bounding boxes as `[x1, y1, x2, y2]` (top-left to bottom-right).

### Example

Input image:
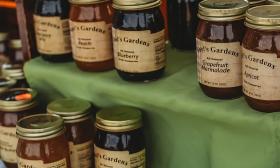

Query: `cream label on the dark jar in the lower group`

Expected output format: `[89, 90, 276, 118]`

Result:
[94, 145, 146, 168]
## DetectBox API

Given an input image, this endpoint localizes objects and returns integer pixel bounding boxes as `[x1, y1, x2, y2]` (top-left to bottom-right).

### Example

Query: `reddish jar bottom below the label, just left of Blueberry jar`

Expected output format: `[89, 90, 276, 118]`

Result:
[75, 59, 114, 72]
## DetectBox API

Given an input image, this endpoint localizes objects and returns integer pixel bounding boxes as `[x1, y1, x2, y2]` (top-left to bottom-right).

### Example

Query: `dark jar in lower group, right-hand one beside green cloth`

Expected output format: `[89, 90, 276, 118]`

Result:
[94, 106, 146, 168]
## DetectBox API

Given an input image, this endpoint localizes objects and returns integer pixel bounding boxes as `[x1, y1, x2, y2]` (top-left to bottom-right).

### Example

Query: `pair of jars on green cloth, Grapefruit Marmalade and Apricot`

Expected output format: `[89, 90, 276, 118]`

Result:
[196, 0, 280, 112]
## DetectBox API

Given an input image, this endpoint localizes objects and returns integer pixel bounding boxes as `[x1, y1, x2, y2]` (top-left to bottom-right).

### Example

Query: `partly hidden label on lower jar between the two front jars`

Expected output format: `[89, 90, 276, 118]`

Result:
[69, 141, 94, 168]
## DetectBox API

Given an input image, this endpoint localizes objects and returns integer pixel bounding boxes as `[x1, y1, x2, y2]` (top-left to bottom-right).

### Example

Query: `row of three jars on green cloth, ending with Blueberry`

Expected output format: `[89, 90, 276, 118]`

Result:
[34, 0, 166, 81]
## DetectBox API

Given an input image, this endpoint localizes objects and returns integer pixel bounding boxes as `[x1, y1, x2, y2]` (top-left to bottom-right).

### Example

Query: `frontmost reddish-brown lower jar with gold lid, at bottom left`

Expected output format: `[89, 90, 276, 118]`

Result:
[16, 114, 71, 168]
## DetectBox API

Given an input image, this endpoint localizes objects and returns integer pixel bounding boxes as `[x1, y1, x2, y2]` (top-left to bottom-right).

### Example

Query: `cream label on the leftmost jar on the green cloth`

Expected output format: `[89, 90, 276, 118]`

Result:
[34, 15, 72, 55]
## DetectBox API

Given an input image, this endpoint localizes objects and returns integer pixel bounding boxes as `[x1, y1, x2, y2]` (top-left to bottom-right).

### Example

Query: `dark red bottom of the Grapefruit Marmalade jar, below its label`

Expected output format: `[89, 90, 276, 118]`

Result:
[199, 83, 242, 100]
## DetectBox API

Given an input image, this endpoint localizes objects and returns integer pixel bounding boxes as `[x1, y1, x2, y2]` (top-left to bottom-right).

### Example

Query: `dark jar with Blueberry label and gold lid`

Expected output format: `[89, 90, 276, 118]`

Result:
[113, 0, 166, 81]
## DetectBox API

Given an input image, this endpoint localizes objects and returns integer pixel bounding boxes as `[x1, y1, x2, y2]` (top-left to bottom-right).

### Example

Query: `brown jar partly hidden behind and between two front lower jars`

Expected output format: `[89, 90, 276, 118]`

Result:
[47, 98, 94, 168]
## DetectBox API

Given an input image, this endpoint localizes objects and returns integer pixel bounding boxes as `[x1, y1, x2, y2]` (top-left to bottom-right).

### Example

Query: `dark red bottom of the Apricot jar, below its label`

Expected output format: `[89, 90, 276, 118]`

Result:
[244, 95, 280, 113]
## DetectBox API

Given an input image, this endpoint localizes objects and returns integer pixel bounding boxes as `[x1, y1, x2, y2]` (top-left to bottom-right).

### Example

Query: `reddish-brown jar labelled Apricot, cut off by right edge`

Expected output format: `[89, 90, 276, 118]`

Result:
[242, 5, 280, 112]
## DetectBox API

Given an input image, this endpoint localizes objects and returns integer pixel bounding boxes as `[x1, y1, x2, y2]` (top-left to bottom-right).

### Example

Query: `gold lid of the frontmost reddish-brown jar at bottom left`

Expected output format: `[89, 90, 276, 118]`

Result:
[16, 114, 65, 140]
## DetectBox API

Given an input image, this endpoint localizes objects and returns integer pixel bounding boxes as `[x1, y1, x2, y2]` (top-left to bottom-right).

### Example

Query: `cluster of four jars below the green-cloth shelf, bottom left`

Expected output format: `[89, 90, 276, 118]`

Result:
[0, 88, 146, 168]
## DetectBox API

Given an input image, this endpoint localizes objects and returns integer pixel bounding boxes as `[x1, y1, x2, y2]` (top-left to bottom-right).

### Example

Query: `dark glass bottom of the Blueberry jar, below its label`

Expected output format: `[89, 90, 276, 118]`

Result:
[117, 68, 165, 82]
